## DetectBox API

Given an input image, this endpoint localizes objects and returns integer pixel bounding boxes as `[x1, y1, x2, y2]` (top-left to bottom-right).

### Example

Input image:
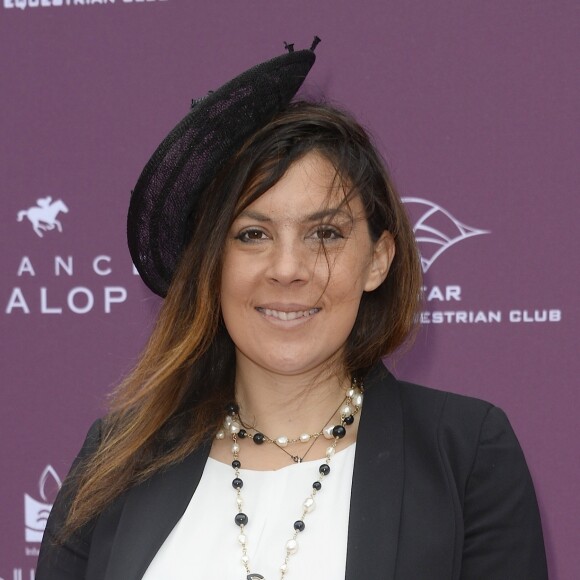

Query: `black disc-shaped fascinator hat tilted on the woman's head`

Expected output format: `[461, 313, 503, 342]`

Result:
[127, 37, 320, 297]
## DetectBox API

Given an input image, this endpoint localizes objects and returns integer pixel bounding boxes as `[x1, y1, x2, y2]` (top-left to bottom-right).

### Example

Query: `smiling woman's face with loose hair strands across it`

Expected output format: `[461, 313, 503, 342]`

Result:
[221, 152, 394, 375]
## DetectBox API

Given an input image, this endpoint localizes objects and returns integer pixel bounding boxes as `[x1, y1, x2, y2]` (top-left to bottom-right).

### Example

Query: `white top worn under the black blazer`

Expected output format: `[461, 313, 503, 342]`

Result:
[143, 444, 356, 580]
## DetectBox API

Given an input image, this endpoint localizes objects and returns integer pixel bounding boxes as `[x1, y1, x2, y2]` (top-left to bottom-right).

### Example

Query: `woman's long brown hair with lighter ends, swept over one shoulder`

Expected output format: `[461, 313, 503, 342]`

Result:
[64, 102, 421, 536]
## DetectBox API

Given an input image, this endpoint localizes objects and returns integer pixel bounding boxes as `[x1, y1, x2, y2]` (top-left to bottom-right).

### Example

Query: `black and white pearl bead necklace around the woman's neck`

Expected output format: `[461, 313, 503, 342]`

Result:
[216, 379, 363, 580]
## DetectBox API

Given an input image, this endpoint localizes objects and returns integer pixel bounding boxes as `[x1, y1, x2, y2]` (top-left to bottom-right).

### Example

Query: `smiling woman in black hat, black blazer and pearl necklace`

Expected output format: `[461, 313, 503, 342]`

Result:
[37, 46, 547, 580]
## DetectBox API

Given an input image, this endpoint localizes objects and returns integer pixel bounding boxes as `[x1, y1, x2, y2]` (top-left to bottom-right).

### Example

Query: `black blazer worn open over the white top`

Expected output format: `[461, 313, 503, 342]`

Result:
[36, 365, 548, 580]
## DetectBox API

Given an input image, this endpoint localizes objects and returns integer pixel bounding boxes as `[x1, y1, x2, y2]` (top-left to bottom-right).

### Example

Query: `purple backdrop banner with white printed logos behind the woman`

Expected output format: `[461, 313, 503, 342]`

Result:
[0, 0, 580, 580]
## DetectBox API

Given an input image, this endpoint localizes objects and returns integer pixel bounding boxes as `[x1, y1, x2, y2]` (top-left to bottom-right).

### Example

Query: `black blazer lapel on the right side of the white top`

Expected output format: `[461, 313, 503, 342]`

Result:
[345, 364, 404, 580]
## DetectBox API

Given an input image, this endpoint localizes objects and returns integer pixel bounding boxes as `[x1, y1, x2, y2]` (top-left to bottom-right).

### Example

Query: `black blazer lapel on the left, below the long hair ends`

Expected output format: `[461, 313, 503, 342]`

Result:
[104, 444, 211, 580]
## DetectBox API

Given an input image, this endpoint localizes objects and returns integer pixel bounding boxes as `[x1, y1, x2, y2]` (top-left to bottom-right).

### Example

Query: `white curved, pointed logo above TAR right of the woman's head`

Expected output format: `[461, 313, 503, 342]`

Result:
[403, 197, 490, 273]
